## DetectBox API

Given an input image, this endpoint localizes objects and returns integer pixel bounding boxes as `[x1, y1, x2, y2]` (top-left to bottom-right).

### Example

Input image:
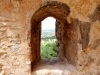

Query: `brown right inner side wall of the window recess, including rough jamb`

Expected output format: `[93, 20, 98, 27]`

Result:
[56, 19, 81, 66]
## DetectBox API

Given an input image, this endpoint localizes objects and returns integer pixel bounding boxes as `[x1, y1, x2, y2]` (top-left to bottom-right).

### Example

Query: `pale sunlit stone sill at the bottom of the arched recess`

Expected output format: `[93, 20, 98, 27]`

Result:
[32, 58, 77, 75]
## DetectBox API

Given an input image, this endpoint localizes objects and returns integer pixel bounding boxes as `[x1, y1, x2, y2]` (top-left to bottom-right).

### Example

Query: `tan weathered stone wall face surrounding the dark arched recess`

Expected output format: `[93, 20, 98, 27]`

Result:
[0, 0, 100, 75]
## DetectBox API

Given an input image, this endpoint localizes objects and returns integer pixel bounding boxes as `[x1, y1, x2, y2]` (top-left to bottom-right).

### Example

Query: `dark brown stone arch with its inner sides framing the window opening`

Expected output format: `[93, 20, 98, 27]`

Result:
[31, 1, 77, 69]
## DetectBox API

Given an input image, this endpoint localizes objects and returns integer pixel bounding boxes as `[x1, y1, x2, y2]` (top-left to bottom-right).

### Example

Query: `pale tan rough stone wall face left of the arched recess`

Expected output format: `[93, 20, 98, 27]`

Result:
[0, 0, 42, 75]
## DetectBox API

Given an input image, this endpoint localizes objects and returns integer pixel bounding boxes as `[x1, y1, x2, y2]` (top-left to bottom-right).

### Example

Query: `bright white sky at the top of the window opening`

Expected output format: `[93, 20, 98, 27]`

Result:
[42, 17, 56, 30]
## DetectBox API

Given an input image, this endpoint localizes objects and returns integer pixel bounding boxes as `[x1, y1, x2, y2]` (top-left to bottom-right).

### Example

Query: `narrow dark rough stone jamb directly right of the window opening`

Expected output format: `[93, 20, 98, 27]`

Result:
[55, 20, 66, 61]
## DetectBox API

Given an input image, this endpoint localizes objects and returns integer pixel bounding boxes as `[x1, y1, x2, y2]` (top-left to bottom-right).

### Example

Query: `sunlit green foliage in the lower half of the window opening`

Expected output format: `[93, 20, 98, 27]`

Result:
[41, 36, 57, 58]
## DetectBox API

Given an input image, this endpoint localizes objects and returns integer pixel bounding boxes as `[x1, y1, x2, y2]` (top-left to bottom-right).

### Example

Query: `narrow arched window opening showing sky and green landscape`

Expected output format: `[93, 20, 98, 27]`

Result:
[40, 17, 57, 59]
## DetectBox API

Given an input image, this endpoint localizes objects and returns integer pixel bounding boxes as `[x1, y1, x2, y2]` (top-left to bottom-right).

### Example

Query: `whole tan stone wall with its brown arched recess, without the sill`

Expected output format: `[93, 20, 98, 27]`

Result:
[0, 0, 100, 75]
